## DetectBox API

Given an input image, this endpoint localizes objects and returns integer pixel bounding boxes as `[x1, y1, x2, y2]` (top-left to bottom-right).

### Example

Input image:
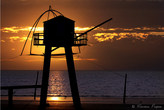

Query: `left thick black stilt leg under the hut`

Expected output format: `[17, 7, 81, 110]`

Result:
[40, 46, 51, 107]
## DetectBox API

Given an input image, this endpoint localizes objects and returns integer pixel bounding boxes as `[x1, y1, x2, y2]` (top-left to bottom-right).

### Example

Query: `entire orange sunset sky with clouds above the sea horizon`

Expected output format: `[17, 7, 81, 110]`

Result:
[1, 0, 164, 70]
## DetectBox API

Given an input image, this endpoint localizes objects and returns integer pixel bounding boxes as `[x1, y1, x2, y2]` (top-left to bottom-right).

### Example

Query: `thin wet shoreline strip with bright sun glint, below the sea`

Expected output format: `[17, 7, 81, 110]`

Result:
[1, 96, 164, 104]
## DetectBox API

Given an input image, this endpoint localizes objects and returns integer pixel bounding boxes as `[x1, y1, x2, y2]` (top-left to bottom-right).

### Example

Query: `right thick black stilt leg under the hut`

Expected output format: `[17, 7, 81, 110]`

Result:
[65, 46, 81, 110]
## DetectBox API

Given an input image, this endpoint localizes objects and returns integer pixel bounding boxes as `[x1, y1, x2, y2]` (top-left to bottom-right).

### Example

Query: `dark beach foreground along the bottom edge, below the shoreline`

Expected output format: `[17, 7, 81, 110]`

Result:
[1, 98, 164, 110]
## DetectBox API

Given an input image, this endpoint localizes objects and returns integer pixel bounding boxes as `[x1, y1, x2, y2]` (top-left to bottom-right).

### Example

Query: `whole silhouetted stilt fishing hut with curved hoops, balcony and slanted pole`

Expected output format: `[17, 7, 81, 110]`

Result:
[21, 7, 112, 110]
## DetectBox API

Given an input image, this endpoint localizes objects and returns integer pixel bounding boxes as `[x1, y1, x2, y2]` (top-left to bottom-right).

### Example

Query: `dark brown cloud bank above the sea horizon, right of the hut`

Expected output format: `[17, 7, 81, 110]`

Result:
[79, 36, 164, 70]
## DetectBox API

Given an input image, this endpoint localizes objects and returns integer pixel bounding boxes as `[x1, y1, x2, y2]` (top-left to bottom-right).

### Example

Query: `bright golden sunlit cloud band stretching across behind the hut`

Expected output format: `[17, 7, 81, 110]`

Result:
[0, 26, 164, 43]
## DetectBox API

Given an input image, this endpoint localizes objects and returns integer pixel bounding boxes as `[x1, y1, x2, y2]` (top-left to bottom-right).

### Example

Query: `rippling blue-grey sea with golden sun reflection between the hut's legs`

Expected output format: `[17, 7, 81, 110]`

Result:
[1, 70, 164, 97]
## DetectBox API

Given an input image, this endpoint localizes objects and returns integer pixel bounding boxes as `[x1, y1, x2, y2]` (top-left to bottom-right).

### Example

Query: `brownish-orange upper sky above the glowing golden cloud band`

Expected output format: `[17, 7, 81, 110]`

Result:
[2, 0, 164, 27]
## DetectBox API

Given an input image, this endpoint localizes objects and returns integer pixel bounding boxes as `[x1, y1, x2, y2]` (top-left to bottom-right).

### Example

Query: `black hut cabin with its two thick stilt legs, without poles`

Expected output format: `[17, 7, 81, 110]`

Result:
[40, 16, 87, 107]
